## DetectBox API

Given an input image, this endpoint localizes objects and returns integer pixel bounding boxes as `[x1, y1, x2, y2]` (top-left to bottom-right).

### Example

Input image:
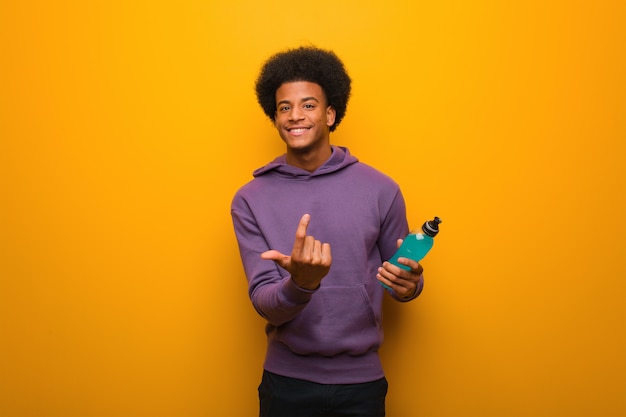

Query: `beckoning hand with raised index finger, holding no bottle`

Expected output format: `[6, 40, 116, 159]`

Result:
[261, 214, 332, 290]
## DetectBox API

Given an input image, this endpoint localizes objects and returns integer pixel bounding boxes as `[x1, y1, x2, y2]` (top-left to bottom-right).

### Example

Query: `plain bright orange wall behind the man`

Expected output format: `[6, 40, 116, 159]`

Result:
[0, 0, 626, 417]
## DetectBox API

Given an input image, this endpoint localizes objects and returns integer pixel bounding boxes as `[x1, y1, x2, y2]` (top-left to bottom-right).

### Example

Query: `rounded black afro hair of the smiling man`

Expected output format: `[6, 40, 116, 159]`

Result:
[255, 46, 351, 132]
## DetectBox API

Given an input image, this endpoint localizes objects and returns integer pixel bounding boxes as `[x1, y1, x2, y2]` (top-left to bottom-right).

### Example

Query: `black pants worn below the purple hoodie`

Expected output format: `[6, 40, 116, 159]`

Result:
[259, 371, 387, 417]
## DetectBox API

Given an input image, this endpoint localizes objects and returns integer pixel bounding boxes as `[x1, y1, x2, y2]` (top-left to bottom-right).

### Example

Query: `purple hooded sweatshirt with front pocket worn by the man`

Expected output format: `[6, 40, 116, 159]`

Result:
[231, 146, 422, 384]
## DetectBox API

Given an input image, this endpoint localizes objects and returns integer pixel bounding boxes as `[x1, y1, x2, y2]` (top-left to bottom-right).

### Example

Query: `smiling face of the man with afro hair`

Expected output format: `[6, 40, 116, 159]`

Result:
[275, 81, 335, 153]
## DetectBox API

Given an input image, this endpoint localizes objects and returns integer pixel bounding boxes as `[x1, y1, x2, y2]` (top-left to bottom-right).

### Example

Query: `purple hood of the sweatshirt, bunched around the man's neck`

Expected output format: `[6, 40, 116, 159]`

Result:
[252, 146, 359, 179]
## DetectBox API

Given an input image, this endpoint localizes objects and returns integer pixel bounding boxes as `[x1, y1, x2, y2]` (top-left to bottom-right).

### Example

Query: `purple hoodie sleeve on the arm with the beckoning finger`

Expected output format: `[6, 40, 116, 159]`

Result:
[231, 194, 315, 326]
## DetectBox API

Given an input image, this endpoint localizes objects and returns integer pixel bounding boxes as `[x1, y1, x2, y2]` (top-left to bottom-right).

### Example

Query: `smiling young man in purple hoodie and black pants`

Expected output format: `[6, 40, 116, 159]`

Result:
[231, 47, 423, 417]
